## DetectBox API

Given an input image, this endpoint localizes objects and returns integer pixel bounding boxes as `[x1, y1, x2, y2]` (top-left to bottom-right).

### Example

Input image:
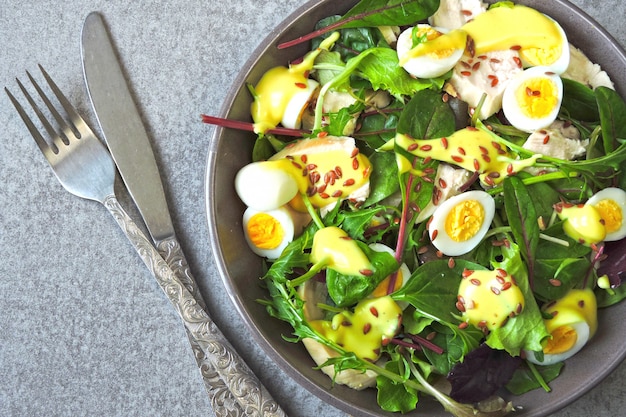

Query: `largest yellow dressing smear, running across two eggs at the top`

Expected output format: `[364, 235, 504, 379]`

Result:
[404, 5, 563, 66]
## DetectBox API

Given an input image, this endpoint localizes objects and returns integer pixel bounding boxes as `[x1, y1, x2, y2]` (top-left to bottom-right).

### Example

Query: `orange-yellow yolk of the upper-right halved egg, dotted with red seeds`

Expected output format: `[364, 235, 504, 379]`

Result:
[515, 77, 558, 119]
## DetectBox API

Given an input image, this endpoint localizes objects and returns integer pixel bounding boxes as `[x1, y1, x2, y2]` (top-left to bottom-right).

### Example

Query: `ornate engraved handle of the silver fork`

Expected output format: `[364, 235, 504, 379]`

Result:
[103, 195, 286, 417]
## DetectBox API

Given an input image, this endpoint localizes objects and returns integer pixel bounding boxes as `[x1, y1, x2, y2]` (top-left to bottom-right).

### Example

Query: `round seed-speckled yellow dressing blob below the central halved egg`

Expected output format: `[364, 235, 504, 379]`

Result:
[457, 269, 525, 331]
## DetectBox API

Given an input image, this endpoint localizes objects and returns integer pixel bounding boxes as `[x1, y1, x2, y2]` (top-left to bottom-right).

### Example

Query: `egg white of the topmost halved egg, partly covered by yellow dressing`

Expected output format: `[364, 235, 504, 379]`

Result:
[396, 24, 463, 78]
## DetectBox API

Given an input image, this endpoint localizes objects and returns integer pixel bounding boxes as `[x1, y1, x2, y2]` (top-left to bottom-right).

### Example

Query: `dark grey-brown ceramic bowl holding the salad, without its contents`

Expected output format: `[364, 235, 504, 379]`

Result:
[206, 0, 626, 417]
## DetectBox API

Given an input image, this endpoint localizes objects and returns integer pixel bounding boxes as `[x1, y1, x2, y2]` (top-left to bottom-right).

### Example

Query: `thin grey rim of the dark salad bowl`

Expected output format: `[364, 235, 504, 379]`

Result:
[204, 0, 626, 417]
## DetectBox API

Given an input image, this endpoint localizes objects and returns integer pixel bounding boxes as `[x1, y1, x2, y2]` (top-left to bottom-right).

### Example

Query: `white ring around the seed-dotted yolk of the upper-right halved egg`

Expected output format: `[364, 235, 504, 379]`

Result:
[502, 67, 563, 133]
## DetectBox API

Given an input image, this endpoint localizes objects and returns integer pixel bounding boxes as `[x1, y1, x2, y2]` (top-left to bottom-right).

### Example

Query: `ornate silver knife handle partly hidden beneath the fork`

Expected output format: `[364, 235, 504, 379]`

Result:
[156, 236, 244, 417]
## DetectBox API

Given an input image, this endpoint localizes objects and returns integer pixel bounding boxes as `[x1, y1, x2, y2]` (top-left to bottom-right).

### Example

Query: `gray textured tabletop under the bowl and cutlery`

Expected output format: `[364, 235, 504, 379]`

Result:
[0, 0, 626, 417]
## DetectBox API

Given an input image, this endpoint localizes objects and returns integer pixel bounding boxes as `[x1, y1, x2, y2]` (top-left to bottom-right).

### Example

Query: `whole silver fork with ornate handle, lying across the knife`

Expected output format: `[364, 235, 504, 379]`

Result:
[4, 66, 286, 417]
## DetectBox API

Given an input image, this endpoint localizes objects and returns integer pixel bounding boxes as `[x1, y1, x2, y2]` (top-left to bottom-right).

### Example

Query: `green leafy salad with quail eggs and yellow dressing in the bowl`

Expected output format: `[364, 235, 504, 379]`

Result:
[204, 0, 626, 416]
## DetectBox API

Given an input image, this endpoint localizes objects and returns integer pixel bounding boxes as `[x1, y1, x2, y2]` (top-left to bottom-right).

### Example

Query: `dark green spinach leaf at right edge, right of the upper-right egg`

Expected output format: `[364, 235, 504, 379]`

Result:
[595, 87, 626, 154]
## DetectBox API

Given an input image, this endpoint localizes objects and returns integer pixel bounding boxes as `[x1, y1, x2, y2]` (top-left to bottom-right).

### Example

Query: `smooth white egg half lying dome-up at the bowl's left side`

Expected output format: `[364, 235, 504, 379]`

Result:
[235, 161, 298, 210]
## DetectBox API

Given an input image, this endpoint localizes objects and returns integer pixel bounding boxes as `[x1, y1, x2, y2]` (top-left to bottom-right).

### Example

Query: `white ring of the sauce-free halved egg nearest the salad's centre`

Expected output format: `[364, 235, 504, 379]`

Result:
[428, 190, 495, 256]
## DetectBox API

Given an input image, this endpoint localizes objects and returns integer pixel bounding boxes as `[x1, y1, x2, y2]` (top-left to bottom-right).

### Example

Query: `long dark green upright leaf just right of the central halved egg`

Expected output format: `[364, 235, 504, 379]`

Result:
[504, 177, 539, 289]
